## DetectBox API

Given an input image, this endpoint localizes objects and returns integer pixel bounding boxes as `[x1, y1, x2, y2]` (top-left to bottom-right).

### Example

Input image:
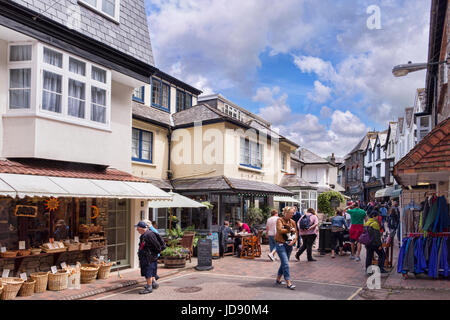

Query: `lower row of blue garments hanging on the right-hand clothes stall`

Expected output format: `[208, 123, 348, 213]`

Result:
[397, 235, 450, 278]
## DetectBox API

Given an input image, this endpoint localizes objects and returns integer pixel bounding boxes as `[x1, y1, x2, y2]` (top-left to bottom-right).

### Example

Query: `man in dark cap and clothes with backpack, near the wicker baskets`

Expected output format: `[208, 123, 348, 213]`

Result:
[135, 221, 166, 294]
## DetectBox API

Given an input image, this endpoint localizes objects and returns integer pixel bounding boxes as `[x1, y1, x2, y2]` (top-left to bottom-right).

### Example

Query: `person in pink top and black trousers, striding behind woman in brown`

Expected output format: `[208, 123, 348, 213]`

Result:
[295, 208, 319, 261]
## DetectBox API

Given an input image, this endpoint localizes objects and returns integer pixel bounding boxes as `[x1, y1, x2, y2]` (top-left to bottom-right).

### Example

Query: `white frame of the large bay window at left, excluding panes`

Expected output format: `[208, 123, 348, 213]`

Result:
[7, 41, 112, 131]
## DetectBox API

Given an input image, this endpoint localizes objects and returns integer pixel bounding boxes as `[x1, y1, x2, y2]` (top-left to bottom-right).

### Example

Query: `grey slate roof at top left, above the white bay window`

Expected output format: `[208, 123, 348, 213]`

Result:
[12, 0, 154, 66]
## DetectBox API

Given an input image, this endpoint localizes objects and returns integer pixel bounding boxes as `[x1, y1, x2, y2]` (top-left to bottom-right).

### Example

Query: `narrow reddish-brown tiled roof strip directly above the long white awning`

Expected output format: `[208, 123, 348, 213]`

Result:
[0, 159, 148, 182]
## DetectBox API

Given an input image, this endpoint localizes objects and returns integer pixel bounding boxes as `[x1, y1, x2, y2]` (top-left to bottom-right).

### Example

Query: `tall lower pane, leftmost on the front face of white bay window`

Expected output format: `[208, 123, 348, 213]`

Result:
[42, 71, 62, 113]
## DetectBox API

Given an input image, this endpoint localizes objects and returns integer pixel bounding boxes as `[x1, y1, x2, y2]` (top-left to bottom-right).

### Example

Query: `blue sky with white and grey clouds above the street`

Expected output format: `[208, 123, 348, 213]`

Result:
[145, 0, 431, 157]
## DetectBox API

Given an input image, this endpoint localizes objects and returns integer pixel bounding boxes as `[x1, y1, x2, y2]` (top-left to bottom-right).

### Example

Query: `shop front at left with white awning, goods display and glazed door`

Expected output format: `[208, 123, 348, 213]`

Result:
[0, 164, 170, 276]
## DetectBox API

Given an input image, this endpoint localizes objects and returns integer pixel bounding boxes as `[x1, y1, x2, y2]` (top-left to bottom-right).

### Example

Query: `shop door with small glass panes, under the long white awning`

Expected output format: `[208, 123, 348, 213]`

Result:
[106, 199, 131, 268]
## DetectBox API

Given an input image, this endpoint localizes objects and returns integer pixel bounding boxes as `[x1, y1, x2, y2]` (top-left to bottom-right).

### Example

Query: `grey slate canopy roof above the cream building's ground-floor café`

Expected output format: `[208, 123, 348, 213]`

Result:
[172, 176, 292, 195]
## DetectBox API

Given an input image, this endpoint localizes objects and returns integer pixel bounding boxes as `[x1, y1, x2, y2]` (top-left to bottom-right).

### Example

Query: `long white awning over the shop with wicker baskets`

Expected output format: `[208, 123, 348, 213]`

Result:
[0, 173, 172, 201]
